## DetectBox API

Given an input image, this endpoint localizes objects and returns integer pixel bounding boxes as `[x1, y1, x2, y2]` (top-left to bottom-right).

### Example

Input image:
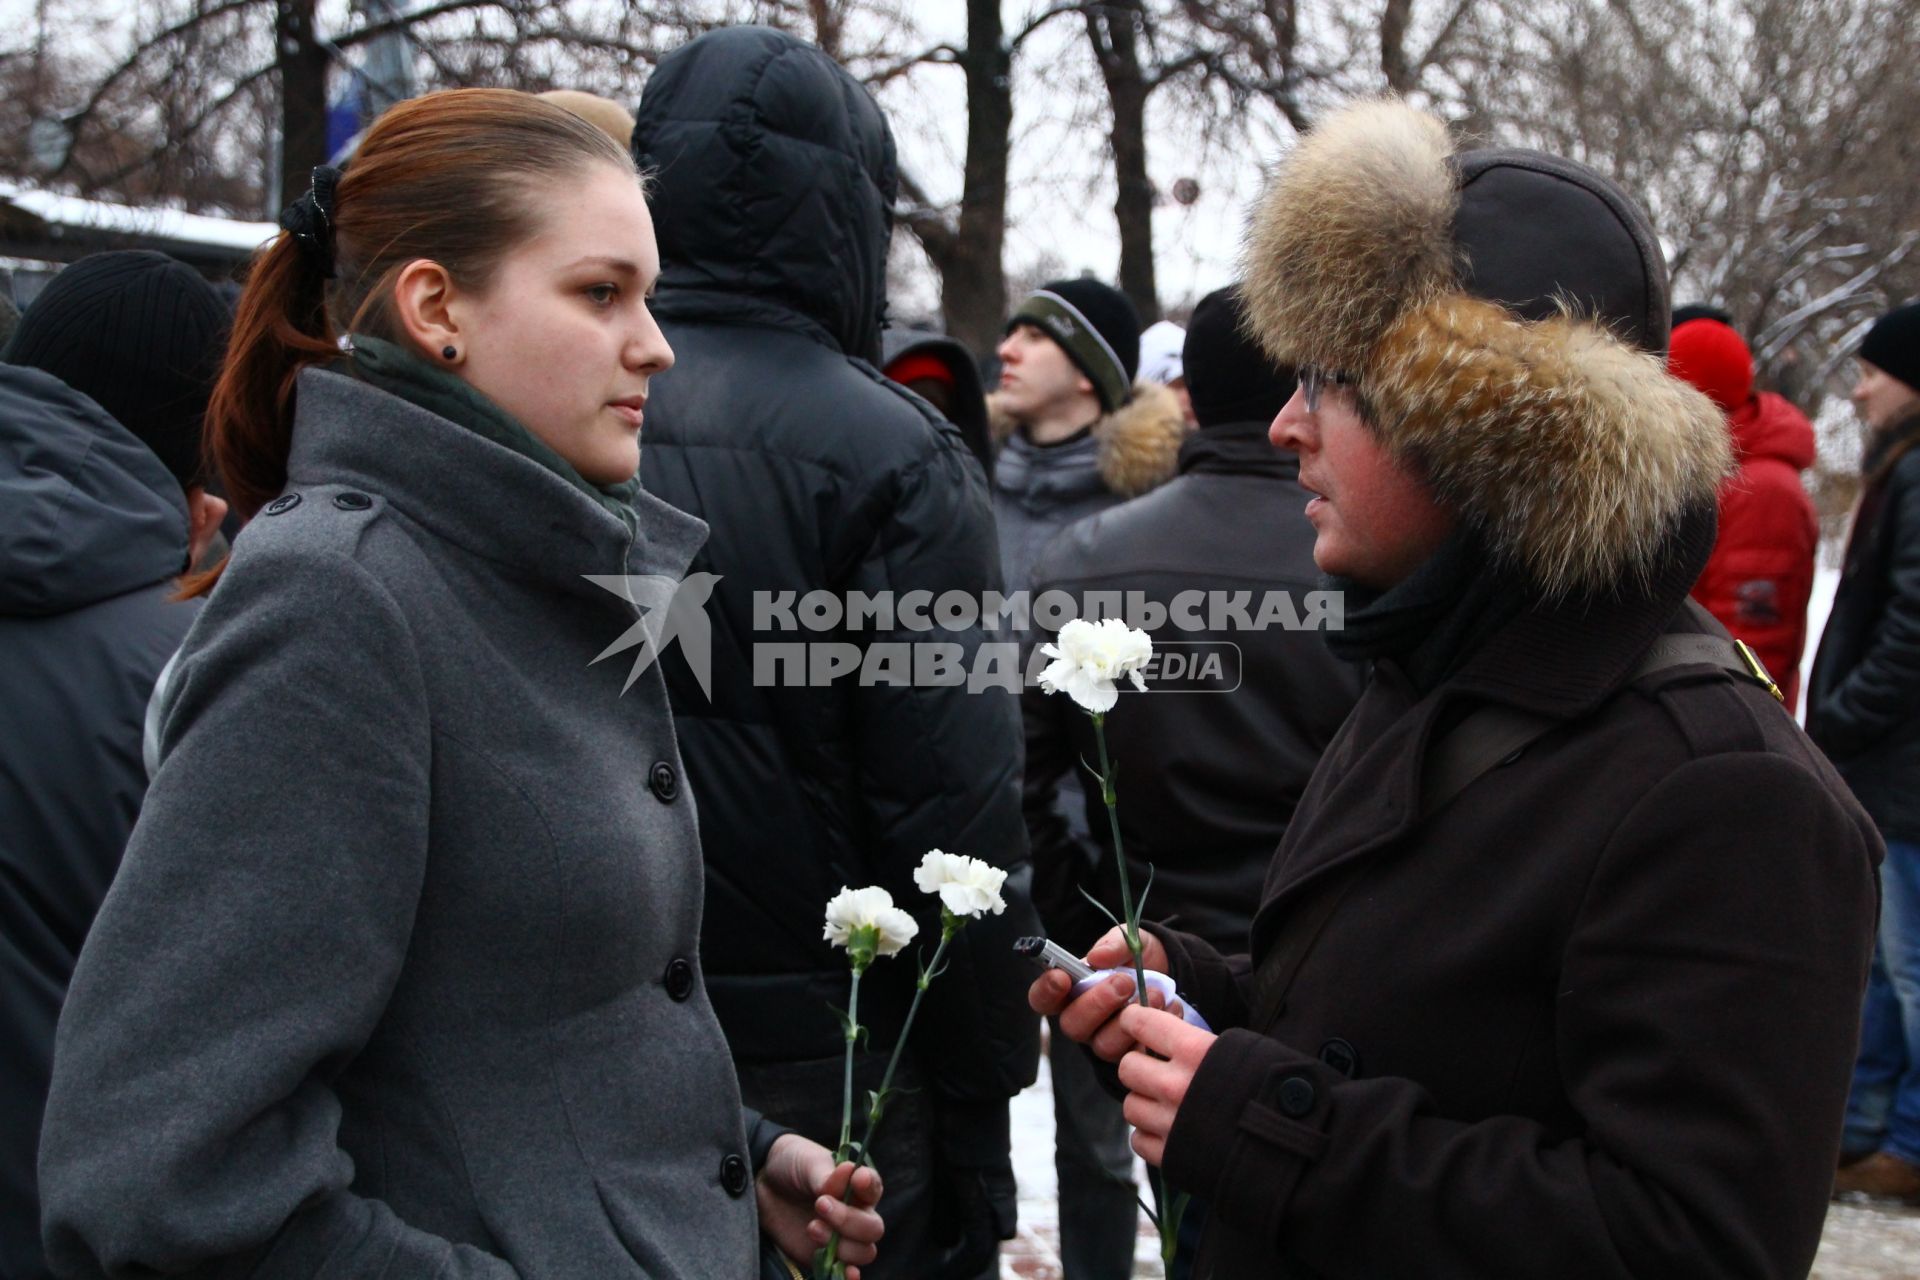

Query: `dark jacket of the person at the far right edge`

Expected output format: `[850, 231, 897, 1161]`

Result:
[1807, 413, 1920, 841]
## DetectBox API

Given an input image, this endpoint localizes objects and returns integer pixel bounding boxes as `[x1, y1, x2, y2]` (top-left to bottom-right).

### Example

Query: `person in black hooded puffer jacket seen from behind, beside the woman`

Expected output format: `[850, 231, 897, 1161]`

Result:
[634, 27, 1039, 1280]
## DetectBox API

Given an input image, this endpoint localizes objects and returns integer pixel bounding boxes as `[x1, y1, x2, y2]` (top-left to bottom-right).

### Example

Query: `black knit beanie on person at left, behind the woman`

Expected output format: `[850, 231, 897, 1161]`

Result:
[8, 249, 230, 489]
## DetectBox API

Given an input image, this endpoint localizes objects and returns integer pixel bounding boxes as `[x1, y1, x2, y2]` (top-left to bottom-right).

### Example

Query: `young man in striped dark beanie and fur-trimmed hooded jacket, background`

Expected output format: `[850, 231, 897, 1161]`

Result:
[987, 276, 1187, 591]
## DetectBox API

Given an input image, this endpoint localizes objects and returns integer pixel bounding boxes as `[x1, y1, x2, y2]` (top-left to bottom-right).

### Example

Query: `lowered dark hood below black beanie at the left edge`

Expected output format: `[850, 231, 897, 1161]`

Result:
[0, 365, 188, 616]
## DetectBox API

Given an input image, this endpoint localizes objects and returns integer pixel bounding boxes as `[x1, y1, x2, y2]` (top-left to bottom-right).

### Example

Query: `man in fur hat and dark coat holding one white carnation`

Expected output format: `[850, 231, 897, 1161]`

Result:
[1031, 102, 1880, 1280]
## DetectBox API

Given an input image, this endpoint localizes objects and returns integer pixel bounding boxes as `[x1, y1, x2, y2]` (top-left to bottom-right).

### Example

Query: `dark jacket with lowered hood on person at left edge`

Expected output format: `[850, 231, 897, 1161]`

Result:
[0, 365, 200, 1280]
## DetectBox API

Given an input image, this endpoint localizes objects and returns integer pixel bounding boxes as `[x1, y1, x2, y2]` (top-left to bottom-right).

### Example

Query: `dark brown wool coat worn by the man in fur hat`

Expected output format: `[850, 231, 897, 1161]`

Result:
[1164, 545, 1880, 1280]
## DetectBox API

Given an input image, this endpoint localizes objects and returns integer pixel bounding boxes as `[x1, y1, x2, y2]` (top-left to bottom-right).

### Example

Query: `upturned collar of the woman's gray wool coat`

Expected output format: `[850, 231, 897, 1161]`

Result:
[286, 368, 707, 595]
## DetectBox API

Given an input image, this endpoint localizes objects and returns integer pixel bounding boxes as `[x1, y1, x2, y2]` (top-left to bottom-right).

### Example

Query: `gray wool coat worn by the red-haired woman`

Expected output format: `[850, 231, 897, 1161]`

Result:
[40, 370, 756, 1280]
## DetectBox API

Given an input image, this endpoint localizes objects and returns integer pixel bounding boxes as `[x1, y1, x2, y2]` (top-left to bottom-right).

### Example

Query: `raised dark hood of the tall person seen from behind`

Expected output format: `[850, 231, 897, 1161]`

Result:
[634, 27, 899, 359]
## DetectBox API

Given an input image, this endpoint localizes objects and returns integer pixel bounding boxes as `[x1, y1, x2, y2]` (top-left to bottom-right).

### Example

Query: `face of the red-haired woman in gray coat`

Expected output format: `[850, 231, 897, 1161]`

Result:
[451, 165, 674, 486]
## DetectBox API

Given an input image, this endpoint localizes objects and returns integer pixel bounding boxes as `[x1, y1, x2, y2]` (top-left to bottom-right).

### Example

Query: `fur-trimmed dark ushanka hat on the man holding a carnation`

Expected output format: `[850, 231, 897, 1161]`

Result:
[1246, 102, 1732, 597]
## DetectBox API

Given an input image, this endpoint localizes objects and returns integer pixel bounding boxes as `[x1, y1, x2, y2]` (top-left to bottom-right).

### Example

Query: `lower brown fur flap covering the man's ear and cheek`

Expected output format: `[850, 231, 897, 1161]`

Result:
[1363, 294, 1734, 595]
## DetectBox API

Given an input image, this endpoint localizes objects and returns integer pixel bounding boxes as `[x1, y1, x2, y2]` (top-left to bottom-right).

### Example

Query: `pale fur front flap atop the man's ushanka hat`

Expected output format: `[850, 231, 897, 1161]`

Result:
[1242, 100, 1459, 372]
